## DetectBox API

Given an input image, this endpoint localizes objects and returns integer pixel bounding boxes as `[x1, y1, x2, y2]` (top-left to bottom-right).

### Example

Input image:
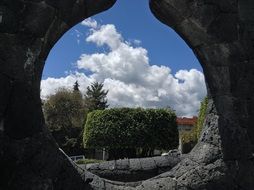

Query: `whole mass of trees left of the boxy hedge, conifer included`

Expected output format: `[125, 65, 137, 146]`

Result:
[43, 81, 108, 155]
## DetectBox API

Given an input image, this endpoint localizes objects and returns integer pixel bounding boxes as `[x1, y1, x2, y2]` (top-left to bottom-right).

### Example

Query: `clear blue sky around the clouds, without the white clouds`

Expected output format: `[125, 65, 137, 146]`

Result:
[43, 0, 202, 79]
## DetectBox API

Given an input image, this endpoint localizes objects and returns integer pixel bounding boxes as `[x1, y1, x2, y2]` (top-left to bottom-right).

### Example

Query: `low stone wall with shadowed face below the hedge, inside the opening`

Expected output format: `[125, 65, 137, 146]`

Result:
[79, 154, 184, 182]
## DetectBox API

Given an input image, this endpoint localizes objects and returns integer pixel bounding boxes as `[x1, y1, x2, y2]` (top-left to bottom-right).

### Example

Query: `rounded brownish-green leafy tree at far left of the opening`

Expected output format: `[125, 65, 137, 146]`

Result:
[43, 89, 87, 155]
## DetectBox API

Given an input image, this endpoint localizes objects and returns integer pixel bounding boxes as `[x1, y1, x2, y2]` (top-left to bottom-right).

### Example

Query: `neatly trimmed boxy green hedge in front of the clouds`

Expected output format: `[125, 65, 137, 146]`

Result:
[83, 108, 178, 150]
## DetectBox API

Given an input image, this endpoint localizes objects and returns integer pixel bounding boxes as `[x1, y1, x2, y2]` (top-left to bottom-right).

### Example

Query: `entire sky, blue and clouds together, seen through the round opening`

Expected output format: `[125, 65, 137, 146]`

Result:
[41, 0, 206, 116]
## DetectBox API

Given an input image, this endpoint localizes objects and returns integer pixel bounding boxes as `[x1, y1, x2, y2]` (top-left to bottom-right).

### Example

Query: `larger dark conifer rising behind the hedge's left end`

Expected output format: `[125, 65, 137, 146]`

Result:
[85, 82, 108, 111]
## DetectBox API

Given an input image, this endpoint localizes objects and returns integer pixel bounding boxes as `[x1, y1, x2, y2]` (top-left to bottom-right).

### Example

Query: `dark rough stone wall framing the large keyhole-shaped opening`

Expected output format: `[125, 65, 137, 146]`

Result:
[0, 0, 254, 189]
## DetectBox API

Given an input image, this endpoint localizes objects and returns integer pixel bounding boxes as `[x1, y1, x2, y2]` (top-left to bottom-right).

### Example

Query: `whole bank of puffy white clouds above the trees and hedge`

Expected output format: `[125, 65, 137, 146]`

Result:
[42, 21, 206, 116]
